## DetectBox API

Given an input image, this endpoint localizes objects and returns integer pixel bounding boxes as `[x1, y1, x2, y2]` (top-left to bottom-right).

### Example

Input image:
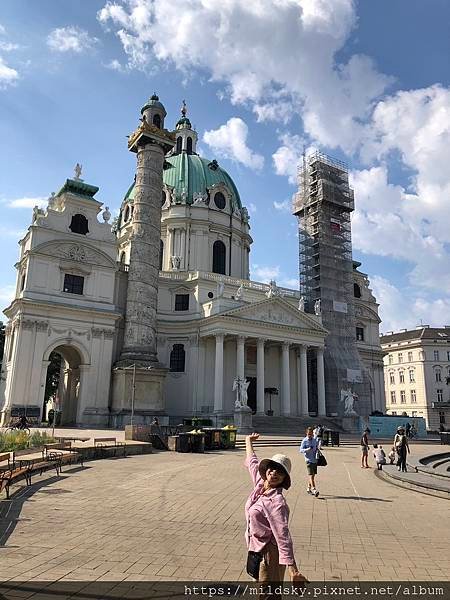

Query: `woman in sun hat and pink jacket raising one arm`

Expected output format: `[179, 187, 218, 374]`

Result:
[245, 433, 306, 600]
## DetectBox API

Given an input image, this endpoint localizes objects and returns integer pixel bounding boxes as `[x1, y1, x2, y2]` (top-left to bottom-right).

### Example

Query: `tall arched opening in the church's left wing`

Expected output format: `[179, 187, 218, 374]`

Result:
[43, 345, 82, 425]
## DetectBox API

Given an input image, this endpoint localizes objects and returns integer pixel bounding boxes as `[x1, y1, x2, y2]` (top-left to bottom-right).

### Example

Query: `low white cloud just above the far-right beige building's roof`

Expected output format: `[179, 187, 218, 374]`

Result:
[370, 276, 450, 333]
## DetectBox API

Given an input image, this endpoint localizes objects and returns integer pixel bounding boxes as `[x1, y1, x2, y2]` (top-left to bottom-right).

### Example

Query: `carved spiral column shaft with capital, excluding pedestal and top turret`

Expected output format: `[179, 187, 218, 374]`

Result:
[120, 102, 174, 367]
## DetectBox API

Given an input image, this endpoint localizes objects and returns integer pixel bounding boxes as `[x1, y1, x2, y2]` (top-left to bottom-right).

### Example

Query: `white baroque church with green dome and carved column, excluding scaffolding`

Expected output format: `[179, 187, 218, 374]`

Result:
[0, 95, 384, 427]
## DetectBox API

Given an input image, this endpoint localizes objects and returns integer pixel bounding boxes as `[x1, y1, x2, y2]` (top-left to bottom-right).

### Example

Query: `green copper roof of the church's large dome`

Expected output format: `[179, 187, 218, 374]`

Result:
[124, 152, 242, 208]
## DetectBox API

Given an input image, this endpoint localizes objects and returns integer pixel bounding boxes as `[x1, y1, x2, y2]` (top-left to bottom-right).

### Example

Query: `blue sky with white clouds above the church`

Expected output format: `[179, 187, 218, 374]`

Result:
[0, 0, 450, 331]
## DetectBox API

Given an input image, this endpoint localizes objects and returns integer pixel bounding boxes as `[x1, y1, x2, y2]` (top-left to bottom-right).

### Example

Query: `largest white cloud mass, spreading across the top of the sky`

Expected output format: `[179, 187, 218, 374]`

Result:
[97, 0, 391, 149]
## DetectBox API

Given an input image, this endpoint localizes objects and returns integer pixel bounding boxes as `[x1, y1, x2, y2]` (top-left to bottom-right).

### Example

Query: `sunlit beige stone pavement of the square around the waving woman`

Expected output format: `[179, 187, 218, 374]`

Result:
[0, 444, 450, 585]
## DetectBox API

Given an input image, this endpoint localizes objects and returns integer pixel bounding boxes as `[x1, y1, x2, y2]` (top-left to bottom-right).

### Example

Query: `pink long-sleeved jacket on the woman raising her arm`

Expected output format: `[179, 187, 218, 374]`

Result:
[244, 454, 294, 565]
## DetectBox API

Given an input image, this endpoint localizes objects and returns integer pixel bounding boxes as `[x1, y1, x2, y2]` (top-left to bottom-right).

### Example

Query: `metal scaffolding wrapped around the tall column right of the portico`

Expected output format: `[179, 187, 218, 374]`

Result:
[293, 152, 371, 415]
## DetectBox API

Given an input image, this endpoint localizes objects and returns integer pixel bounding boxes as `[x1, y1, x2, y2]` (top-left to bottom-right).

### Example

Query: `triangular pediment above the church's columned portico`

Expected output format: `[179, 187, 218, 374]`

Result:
[220, 297, 326, 333]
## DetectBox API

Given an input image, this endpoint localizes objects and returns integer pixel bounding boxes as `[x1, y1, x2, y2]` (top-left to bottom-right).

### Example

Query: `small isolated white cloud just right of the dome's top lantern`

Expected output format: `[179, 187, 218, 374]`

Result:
[203, 117, 264, 170]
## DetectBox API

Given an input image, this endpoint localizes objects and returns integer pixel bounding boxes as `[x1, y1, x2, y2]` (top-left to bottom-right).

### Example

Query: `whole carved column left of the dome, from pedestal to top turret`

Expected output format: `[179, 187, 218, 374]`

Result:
[111, 95, 175, 427]
